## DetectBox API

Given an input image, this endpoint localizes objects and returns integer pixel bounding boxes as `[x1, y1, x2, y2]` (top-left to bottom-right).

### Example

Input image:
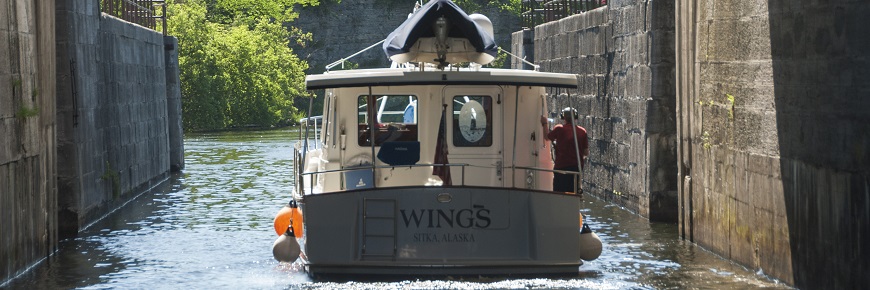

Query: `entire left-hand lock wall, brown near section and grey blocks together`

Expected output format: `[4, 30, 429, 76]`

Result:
[0, 0, 184, 287]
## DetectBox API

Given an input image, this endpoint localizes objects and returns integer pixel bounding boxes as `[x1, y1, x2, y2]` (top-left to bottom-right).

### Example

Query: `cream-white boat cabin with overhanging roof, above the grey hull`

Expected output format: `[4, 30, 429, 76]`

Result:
[297, 68, 577, 194]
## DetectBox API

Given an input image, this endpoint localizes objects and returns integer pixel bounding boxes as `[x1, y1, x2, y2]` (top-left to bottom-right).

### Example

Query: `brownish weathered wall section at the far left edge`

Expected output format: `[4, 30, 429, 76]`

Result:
[0, 0, 58, 286]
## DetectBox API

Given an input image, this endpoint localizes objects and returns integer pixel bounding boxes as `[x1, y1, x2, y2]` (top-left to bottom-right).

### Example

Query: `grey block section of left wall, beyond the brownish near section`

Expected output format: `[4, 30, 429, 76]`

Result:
[57, 0, 180, 237]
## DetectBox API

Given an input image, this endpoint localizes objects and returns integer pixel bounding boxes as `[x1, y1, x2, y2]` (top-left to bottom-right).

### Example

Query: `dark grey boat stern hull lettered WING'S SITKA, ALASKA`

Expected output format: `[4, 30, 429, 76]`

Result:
[303, 186, 582, 275]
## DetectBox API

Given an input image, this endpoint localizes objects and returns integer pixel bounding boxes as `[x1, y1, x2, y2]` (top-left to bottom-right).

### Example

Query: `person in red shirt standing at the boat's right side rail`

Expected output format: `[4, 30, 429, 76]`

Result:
[541, 107, 589, 192]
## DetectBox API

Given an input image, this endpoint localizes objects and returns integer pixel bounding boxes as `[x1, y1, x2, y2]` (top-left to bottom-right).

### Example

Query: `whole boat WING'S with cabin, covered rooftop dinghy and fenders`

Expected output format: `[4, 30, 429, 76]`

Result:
[273, 0, 602, 277]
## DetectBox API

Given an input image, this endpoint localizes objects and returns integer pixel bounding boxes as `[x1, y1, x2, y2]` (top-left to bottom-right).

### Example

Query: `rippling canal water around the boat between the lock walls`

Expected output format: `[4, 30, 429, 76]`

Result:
[5, 129, 788, 289]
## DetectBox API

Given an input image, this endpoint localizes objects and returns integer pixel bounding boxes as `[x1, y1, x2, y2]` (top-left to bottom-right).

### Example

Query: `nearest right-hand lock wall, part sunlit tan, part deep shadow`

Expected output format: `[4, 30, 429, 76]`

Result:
[676, 0, 870, 289]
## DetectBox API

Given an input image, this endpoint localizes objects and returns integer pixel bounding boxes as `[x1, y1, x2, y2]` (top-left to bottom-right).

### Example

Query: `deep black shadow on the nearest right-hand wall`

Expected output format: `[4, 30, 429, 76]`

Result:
[768, 0, 870, 289]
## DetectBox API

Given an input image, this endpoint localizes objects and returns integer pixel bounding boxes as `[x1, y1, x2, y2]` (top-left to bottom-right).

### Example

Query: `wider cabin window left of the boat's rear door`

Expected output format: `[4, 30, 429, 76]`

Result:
[357, 95, 418, 146]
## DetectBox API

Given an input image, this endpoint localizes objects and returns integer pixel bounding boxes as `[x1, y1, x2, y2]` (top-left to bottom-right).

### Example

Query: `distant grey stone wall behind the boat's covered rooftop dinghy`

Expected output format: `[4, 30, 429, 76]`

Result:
[292, 0, 520, 74]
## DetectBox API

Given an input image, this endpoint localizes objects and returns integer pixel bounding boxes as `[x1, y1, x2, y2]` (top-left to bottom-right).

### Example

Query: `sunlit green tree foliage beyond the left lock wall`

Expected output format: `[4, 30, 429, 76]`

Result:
[167, 0, 319, 131]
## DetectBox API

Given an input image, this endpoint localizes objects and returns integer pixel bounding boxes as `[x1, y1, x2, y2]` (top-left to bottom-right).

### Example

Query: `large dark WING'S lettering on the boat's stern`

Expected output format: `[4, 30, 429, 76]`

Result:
[399, 205, 492, 229]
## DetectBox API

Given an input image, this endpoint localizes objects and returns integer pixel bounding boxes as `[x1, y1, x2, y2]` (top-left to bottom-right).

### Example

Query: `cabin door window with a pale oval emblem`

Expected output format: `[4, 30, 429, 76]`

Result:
[453, 96, 492, 147]
